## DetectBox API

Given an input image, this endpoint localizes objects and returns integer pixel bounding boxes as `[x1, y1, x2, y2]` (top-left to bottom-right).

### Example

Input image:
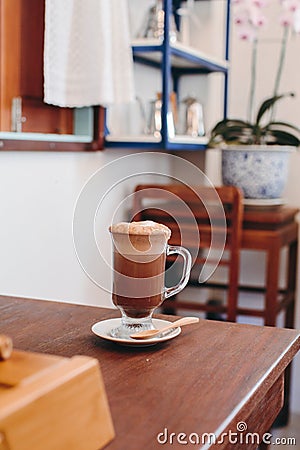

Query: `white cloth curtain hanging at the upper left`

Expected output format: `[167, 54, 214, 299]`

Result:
[44, 0, 134, 107]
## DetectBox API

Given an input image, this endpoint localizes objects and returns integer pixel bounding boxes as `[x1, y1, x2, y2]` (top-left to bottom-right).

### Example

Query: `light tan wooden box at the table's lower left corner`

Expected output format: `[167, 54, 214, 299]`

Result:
[0, 351, 114, 450]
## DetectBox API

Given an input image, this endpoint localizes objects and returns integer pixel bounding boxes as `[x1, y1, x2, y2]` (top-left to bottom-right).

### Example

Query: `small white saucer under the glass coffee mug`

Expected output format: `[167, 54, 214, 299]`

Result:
[91, 318, 181, 347]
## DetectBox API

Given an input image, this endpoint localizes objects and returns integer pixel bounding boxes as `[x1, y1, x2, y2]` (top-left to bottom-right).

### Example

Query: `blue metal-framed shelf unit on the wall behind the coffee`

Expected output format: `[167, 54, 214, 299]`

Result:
[105, 0, 230, 151]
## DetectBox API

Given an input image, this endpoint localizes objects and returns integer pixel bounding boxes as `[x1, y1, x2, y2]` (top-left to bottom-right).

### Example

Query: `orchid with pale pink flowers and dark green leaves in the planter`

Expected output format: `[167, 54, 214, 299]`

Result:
[210, 0, 300, 147]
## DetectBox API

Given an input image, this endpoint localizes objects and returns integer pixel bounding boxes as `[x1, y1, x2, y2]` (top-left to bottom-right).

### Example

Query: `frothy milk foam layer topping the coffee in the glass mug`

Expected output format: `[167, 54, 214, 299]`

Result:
[109, 220, 171, 256]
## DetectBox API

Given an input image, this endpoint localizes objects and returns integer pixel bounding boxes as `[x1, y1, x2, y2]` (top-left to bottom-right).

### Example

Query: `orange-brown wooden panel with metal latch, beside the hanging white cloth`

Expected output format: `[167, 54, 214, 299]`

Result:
[0, 0, 73, 134]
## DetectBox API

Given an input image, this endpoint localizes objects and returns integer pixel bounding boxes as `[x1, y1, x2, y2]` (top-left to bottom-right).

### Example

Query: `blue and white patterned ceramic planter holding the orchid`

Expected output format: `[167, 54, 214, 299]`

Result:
[222, 145, 294, 199]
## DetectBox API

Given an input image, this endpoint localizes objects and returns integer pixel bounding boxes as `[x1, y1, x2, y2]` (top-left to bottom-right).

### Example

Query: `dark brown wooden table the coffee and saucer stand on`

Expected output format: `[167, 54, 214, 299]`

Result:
[0, 296, 300, 450]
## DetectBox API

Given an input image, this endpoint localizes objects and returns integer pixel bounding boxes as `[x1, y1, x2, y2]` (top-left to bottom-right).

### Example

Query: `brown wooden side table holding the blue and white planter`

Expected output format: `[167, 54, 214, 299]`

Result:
[239, 206, 298, 328]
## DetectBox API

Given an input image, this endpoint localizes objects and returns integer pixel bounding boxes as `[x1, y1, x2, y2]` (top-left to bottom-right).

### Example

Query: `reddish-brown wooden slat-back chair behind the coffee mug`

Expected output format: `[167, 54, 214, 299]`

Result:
[132, 184, 243, 321]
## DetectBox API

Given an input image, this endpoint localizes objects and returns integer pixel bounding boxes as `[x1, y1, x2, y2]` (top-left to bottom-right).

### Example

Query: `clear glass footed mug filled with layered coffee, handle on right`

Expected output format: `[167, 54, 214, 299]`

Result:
[109, 221, 192, 339]
